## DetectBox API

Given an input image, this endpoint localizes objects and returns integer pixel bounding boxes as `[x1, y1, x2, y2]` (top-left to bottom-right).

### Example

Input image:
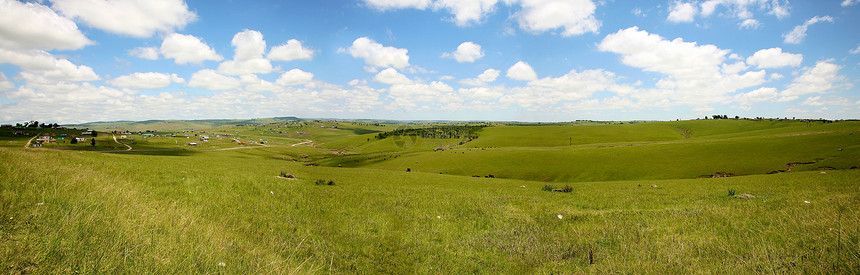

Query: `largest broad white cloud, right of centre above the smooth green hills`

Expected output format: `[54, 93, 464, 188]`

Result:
[598, 27, 767, 105]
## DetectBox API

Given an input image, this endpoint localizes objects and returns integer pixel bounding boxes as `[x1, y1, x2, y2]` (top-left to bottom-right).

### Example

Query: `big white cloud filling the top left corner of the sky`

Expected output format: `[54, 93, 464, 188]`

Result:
[0, 0, 95, 50]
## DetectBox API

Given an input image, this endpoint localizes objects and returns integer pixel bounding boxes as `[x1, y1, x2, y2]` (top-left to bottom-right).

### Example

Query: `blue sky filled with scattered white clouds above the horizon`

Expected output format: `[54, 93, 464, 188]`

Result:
[0, 0, 860, 124]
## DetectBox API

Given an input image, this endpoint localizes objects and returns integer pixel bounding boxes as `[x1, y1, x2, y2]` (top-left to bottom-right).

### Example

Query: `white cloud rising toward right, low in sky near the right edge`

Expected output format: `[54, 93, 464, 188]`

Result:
[779, 60, 851, 101]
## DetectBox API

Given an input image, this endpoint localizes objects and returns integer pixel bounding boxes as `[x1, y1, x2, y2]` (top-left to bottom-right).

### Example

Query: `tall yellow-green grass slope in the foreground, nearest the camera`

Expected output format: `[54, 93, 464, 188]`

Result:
[0, 148, 860, 274]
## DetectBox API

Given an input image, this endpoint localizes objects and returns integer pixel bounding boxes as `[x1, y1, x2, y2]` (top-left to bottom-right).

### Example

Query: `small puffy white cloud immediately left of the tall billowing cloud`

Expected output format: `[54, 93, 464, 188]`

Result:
[160, 33, 224, 65]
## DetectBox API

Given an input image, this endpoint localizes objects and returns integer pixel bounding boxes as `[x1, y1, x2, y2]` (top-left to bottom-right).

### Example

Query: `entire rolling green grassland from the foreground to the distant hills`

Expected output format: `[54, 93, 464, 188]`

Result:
[0, 120, 860, 274]
